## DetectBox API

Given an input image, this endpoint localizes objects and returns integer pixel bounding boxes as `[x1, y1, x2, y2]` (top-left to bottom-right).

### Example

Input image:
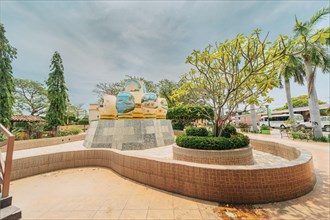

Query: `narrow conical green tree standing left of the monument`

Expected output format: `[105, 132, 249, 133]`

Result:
[46, 51, 69, 129]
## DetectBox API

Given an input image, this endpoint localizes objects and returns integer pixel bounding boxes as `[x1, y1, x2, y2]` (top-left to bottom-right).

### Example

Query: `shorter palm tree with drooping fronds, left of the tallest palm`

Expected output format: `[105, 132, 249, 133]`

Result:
[279, 55, 306, 119]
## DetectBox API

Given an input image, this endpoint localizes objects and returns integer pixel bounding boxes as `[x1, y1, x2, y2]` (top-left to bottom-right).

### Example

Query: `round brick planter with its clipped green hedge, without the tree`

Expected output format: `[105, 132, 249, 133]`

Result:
[173, 126, 253, 165]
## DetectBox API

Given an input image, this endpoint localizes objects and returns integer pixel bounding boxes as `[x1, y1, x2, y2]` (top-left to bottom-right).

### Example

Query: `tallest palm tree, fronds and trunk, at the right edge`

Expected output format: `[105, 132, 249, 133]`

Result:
[294, 6, 330, 137]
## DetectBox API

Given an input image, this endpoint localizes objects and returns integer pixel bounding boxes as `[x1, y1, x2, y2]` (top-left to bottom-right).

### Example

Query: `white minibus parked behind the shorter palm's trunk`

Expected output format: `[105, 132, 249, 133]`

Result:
[259, 114, 304, 129]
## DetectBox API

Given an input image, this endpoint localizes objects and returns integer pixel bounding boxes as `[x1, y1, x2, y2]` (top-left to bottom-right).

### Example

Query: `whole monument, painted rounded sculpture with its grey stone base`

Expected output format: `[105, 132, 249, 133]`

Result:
[84, 79, 174, 150]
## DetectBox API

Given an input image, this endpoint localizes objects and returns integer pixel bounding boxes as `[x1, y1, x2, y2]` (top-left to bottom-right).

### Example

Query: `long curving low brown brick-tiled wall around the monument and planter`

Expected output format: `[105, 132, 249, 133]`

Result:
[12, 138, 315, 204]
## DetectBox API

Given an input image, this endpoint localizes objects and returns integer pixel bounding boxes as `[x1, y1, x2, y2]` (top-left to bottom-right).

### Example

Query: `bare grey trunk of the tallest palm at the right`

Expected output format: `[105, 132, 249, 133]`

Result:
[304, 59, 323, 137]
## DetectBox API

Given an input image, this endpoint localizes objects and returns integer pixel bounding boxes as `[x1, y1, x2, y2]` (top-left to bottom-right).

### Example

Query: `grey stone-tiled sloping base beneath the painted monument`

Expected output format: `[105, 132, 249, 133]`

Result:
[84, 119, 174, 150]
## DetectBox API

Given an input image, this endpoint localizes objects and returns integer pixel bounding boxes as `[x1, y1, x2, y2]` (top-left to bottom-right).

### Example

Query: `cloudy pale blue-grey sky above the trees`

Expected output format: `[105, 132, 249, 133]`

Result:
[0, 0, 330, 109]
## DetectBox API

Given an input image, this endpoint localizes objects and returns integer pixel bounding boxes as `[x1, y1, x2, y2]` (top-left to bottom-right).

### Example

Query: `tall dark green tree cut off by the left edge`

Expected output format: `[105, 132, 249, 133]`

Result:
[0, 23, 17, 127]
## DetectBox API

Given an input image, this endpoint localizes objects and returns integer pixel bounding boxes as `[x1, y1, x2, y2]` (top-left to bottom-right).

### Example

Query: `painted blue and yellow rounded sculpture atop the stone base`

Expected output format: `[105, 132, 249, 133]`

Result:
[90, 79, 168, 119]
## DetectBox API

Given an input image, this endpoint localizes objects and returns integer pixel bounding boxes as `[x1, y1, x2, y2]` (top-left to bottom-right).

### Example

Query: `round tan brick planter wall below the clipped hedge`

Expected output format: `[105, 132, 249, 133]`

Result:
[173, 144, 254, 165]
